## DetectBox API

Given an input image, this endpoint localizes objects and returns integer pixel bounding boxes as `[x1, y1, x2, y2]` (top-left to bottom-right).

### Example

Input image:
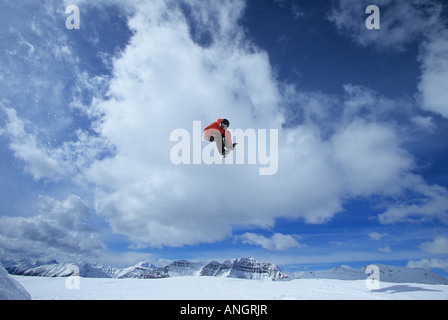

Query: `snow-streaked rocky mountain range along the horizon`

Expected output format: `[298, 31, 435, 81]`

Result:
[1, 257, 448, 285]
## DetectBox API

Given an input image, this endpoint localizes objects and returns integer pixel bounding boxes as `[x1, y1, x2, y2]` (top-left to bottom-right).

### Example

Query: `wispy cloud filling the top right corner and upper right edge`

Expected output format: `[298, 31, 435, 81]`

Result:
[329, 0, 448, 118]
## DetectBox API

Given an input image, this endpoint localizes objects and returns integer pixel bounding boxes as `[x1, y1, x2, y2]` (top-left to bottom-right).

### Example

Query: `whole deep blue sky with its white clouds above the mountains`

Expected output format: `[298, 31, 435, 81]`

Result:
[0, 0, 448, 274]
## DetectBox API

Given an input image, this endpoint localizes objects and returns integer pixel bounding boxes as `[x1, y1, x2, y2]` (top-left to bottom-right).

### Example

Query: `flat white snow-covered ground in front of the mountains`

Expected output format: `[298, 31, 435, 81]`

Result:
[13, 276, 448, 300]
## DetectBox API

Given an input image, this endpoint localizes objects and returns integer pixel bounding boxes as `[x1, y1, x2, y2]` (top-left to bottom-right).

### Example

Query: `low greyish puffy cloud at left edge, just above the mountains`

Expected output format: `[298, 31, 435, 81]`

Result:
[0, 195, 105, 258]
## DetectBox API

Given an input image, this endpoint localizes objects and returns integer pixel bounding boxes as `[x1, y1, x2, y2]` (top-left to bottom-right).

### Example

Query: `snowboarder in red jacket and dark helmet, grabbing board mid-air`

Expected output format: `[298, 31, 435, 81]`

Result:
[204, 119, 237, 158]
